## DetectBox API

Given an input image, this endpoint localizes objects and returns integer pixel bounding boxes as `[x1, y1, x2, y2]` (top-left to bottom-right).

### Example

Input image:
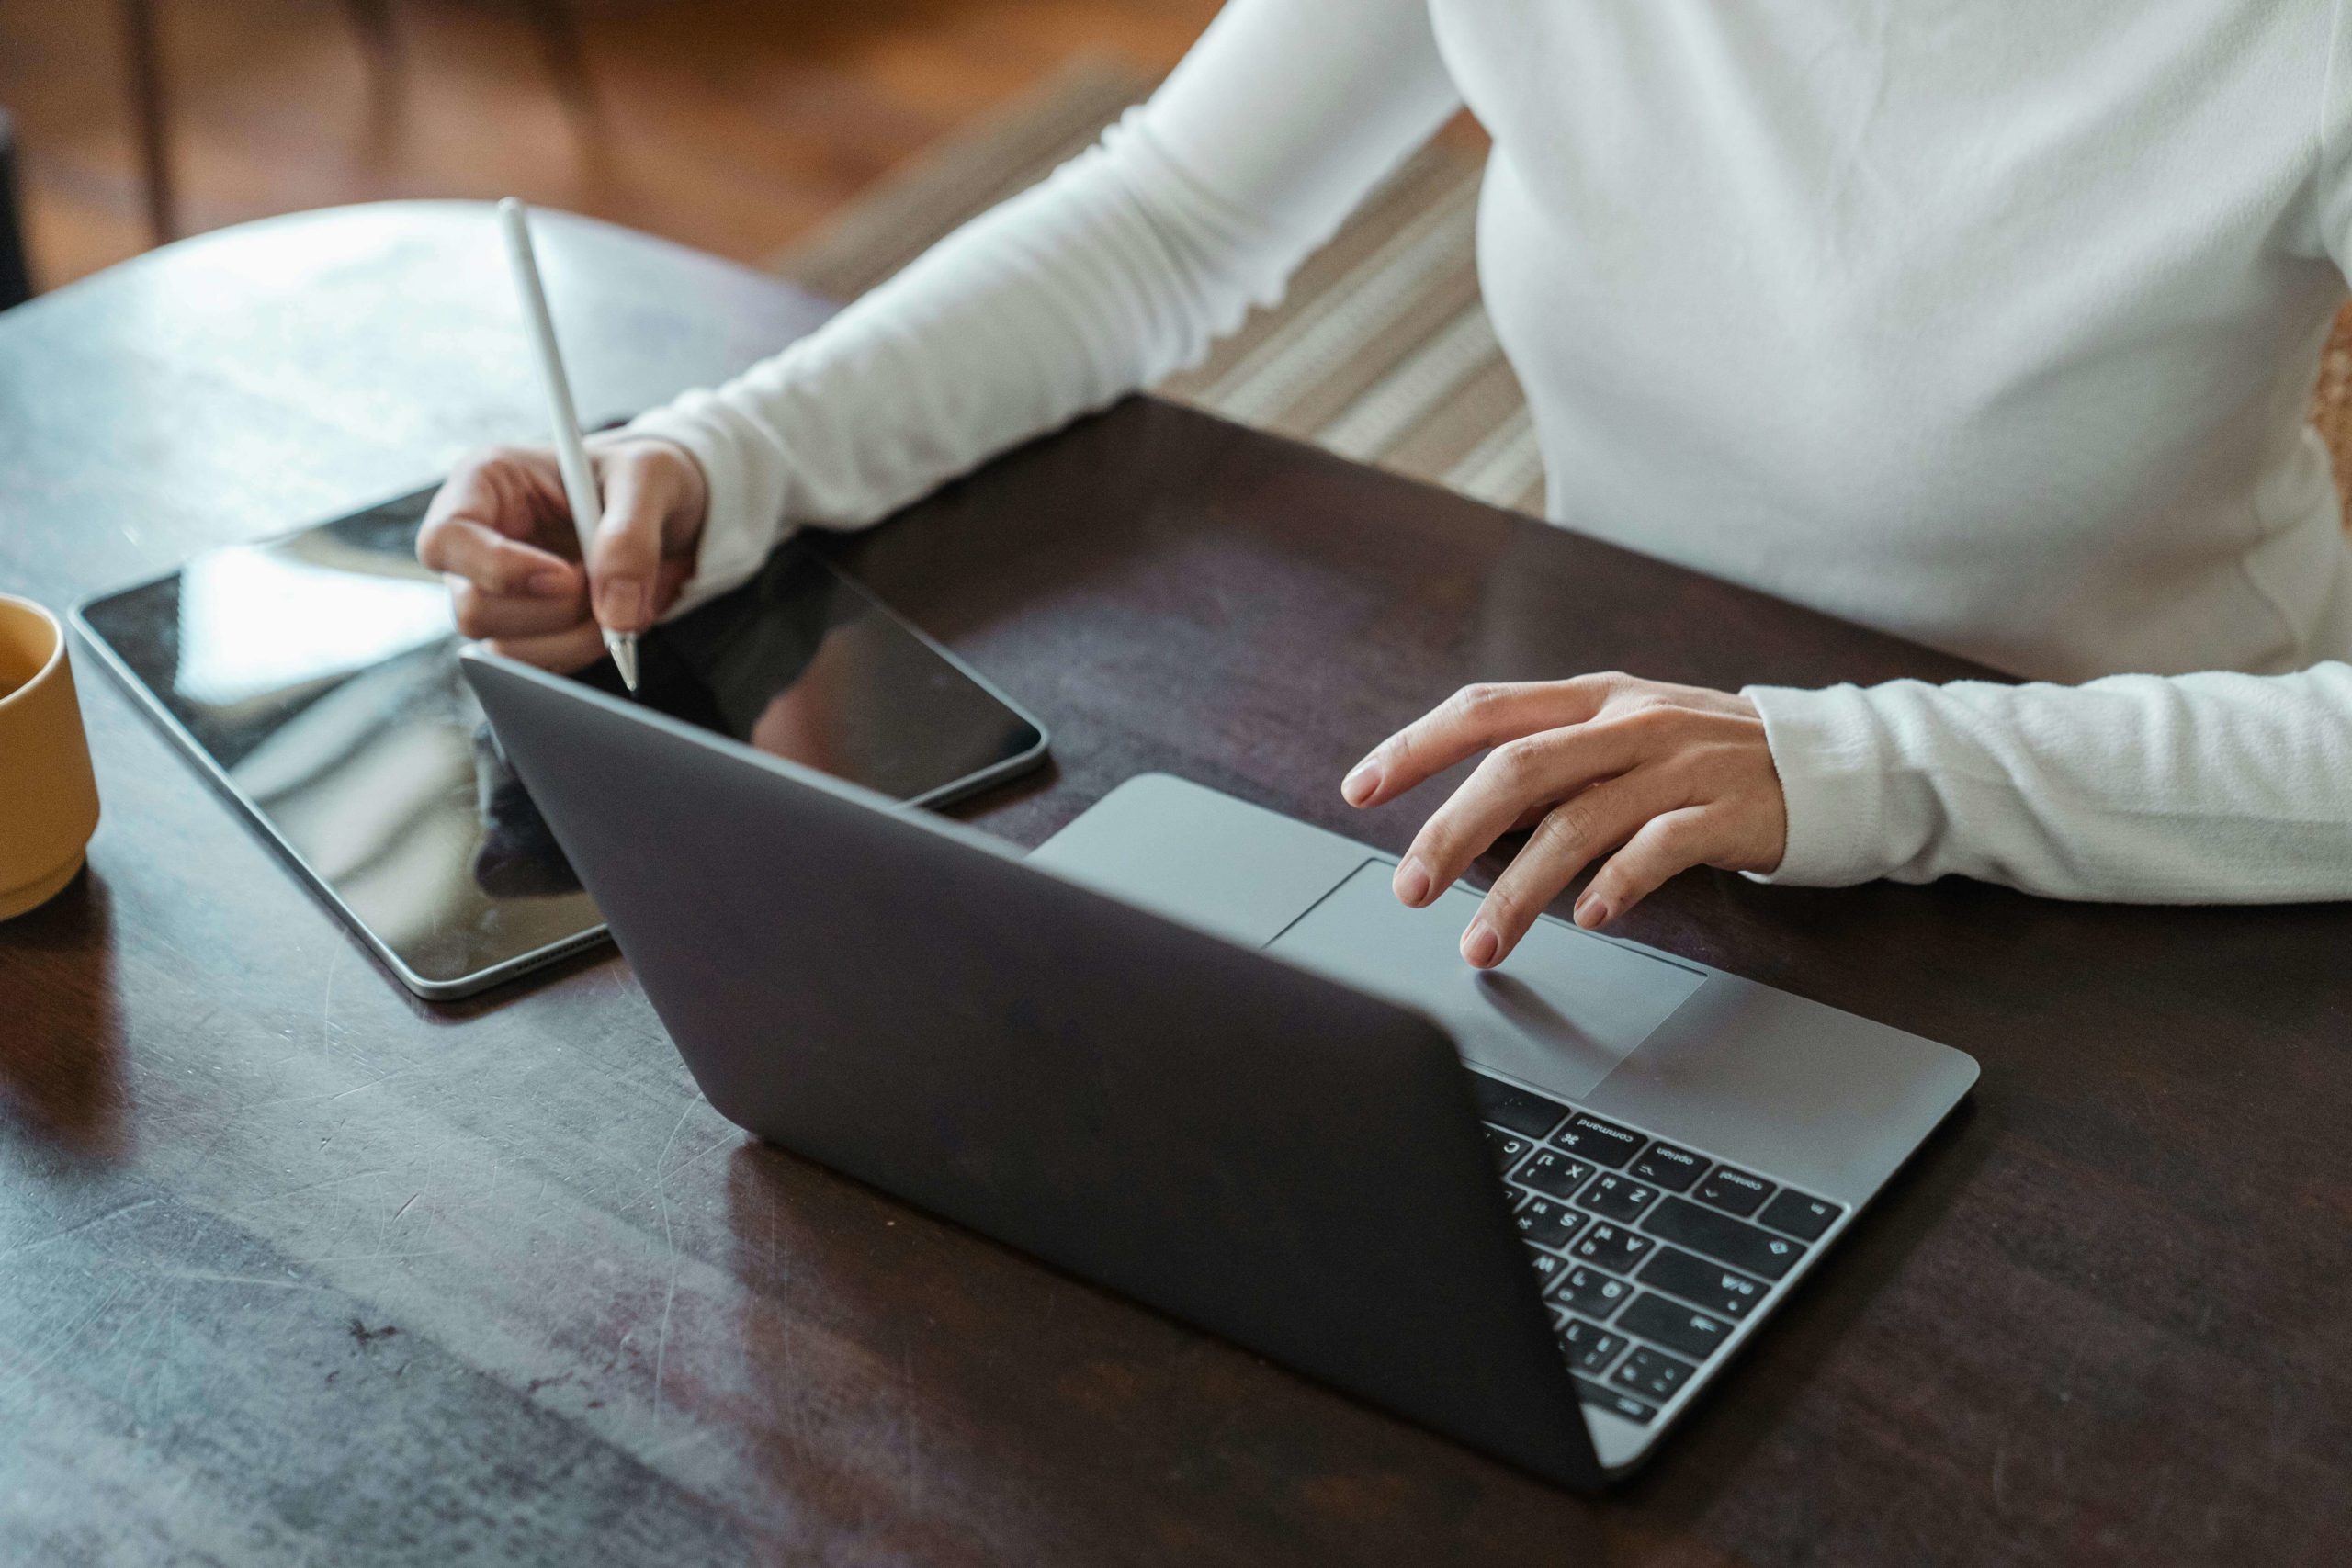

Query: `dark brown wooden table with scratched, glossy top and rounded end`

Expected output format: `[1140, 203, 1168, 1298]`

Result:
[0, 205, 2352, 1565]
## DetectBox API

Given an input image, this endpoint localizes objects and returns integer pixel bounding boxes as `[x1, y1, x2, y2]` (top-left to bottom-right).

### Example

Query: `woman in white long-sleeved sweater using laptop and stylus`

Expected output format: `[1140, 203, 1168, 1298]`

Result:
[419, 0, 2352, 966]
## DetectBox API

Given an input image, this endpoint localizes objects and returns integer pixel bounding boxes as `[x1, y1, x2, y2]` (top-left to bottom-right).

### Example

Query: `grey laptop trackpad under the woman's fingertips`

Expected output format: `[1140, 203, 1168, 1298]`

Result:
[1265, 861, 1708, 1100]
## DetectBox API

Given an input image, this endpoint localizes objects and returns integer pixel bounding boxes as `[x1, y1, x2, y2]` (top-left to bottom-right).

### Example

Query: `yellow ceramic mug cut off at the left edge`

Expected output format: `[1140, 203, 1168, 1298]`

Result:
[0, 592, 99, 919]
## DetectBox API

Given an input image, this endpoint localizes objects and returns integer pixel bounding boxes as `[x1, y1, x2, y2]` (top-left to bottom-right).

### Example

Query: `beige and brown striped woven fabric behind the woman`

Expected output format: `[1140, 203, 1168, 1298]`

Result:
[772, 62, 2352, 526]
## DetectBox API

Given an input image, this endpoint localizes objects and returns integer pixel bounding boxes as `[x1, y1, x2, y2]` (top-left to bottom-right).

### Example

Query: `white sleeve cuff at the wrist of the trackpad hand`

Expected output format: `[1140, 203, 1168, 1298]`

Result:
[1740, 686, 1889, 886]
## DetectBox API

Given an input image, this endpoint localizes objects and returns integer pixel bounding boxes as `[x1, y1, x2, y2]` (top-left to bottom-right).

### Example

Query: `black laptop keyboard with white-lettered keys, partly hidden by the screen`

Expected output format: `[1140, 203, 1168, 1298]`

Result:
[1470, 1072, 1847, 1425]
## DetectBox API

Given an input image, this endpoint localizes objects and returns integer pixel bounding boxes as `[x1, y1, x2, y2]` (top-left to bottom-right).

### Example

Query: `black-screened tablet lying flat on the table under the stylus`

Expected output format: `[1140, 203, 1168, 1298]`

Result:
[73, 489, 1046, 999]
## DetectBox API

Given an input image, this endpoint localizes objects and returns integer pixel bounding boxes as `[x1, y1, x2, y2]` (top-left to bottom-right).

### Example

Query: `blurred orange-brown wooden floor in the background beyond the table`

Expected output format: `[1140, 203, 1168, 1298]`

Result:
[0, 0, 1216, 289]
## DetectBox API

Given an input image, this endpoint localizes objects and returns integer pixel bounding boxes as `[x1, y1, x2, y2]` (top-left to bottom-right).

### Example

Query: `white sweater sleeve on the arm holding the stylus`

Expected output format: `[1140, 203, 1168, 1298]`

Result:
[630, 0, 1458, 614]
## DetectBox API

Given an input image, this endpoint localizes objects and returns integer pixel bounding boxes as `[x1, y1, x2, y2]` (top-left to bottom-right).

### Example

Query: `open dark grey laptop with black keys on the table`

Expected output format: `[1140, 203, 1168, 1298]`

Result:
[463, 651, 1978, 1491]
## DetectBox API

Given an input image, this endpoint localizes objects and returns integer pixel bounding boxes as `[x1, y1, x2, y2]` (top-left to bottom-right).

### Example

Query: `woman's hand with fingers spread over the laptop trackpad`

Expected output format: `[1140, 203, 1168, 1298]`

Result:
[1340, 674, 1788, 968]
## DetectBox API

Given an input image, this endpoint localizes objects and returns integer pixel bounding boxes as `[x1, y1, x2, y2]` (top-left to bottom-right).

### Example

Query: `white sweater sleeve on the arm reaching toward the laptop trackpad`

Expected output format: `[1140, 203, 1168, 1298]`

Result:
[1746, 663, 2352, 903]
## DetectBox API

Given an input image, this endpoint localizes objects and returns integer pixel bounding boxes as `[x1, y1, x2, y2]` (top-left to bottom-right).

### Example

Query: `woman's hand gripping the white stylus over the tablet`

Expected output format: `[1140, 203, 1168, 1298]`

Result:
[416, 434, 710, 670]
